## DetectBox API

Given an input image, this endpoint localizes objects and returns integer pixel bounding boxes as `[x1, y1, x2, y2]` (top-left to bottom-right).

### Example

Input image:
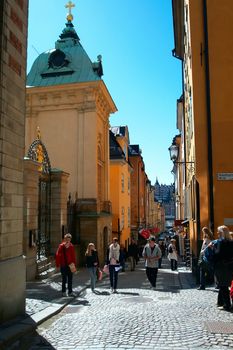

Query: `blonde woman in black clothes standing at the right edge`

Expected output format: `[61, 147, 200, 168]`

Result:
[205, 225, 233, 311]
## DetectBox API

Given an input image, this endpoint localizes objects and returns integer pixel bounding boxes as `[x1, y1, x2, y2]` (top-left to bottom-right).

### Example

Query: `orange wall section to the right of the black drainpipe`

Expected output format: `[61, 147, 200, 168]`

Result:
[208, 0, 233, 234]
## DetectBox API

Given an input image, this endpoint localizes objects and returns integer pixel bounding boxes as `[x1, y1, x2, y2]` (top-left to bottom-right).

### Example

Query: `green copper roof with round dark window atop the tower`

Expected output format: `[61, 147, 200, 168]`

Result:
[27, 20, 103, 86]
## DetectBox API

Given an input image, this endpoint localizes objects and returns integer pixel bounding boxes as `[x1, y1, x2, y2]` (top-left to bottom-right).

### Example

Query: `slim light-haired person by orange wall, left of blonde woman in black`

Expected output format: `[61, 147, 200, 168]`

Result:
[197, 226, 213, 290]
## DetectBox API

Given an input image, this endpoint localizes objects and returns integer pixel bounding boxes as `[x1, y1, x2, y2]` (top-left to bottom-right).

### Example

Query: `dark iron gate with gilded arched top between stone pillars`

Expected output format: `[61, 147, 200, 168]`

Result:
[27, 129, 51, 260]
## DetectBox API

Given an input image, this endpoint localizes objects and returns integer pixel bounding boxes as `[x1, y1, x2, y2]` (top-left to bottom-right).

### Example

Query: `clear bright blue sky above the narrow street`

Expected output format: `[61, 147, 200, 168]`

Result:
[28, 0, 181, 184]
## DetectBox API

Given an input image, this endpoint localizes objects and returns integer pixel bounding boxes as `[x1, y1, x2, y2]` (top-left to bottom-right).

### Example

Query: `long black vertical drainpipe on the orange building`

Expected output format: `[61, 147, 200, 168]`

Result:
[203, 0, 214, 231]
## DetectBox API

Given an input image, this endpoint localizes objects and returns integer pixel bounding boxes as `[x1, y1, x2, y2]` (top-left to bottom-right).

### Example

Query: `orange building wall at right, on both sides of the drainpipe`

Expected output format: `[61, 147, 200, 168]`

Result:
[189, 0, 233, 237]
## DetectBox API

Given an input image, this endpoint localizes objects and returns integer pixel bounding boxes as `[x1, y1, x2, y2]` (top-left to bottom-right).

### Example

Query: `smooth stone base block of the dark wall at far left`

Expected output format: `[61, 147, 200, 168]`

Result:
[0, 256, 26, 323]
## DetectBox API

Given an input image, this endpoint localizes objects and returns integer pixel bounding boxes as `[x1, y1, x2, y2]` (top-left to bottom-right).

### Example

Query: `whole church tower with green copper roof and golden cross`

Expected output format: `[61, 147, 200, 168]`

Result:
[26, 1, 117, 257]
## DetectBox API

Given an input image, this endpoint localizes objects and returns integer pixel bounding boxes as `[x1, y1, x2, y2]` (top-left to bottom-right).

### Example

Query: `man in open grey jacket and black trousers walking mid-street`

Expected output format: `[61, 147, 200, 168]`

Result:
[142, 236, 162, 288]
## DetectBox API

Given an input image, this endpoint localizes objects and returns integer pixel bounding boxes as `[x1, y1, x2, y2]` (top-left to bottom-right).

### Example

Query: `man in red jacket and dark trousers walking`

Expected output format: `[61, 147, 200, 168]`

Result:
[56, 233, 76, 297]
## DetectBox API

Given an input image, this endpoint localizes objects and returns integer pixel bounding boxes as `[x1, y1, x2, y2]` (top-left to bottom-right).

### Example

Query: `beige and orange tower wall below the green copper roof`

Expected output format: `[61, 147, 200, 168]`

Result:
[25, 82, 114, 201]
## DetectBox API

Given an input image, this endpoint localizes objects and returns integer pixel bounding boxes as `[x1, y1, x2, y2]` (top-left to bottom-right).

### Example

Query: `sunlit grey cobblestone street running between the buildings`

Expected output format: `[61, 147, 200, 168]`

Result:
[12, 261, 233, 350]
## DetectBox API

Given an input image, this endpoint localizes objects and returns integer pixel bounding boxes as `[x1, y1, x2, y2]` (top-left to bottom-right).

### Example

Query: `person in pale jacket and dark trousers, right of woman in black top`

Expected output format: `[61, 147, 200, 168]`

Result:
[108, 238, 120, 293]
